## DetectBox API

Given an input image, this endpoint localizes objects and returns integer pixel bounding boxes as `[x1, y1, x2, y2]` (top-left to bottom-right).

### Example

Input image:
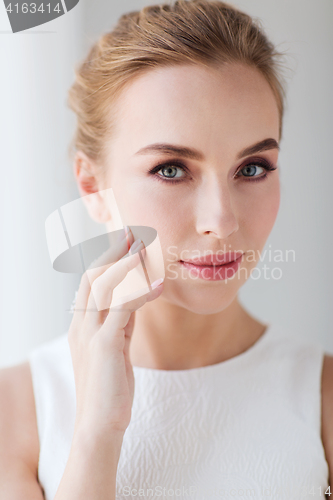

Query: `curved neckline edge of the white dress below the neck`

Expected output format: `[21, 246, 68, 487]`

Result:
[133, 324, 275, 377]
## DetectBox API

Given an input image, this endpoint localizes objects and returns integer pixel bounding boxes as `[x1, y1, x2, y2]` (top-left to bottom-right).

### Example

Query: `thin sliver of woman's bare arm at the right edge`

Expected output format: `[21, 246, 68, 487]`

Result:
[321, 354, 333, 486]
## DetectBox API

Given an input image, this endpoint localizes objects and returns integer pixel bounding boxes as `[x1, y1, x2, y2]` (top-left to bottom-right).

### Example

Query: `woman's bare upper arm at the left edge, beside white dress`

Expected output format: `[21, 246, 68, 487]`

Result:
[0, 361, 43, 500]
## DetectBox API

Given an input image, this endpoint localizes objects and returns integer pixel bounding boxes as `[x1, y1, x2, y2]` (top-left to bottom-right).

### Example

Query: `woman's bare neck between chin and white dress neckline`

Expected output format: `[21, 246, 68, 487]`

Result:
[130, 297, 266, 370]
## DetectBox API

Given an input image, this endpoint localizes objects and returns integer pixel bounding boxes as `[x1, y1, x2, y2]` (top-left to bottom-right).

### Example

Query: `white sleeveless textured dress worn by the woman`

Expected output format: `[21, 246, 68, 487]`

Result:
[29, 325, 329, 500]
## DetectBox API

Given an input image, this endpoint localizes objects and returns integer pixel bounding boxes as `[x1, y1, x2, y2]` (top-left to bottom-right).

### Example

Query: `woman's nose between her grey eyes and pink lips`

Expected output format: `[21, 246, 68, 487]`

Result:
[195, 176, 239, 240]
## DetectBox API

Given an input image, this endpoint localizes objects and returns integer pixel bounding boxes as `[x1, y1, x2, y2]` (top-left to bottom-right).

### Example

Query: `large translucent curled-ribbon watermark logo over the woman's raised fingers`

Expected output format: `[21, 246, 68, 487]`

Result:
[45, 188, 165, 312]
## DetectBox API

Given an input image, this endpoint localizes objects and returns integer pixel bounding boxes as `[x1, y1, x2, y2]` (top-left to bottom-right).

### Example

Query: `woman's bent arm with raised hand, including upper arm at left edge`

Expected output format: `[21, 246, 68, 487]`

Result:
[0, 235, 163, 500]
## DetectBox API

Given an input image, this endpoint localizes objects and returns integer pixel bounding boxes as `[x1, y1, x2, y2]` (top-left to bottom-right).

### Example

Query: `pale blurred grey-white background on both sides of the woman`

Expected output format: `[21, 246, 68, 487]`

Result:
[0, 0, 333, 366]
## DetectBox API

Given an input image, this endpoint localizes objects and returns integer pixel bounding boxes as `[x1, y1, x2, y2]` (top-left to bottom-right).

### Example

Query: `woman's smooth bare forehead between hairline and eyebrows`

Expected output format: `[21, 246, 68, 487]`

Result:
[107, 64, 279, 158]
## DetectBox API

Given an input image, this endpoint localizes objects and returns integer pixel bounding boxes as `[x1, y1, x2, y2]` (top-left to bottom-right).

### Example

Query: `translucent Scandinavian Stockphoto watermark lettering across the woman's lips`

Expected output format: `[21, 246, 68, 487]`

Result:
[166, 244, 296, 281]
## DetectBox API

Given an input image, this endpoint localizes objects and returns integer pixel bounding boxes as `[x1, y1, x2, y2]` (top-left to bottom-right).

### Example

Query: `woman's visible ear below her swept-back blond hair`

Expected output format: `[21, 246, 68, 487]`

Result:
[74, 151, 111, 223]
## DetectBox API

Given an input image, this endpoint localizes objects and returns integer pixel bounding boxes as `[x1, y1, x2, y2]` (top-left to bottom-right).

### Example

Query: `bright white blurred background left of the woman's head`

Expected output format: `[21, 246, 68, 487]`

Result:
[0, 3, 82, 366]
